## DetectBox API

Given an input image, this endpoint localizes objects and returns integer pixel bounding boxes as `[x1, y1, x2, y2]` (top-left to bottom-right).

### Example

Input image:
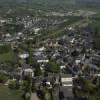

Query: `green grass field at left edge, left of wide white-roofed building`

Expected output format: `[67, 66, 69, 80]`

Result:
[0, 51, 15, 62]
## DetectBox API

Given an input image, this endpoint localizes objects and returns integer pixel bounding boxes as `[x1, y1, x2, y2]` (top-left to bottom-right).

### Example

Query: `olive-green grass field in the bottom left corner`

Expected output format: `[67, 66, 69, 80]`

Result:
[0, 85, 23, 100]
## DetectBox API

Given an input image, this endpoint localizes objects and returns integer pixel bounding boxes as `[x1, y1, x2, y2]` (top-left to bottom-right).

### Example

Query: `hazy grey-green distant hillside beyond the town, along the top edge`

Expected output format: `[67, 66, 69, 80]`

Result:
[0, 0, 100, 9]
